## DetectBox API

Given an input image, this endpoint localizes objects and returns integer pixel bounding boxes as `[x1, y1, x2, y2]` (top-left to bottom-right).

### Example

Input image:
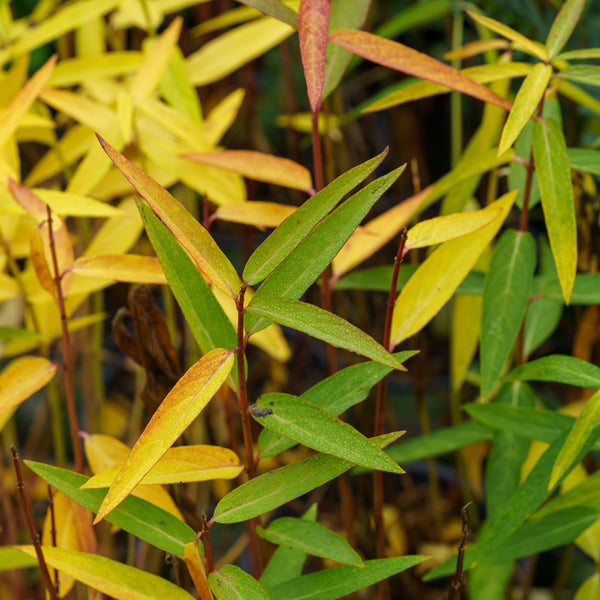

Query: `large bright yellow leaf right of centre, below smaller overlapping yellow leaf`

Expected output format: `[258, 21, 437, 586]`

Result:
[391, 191, 516, 346]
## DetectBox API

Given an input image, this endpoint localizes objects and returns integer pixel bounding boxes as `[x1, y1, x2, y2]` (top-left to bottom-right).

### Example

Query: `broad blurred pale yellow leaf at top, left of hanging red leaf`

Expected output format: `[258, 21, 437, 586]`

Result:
[187, 17, 294, 86]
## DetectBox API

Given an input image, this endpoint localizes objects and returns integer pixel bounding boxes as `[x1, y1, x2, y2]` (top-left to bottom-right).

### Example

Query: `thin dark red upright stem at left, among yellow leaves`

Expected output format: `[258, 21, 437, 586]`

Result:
[47, 206, 83, 473]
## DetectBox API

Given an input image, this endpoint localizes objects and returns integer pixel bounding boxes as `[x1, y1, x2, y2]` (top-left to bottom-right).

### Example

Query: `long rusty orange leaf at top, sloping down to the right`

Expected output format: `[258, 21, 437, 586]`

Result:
[329, 29, 512, 110]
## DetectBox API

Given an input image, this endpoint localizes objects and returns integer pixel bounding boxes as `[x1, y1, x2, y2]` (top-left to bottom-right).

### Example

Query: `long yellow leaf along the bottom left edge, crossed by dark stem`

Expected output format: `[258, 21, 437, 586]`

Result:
[17, 546, 193, 600]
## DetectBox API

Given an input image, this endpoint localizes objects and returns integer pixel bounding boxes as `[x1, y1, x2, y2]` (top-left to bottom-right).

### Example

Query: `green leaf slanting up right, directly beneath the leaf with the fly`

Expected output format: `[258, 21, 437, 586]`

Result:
[212, 432, 400, 523]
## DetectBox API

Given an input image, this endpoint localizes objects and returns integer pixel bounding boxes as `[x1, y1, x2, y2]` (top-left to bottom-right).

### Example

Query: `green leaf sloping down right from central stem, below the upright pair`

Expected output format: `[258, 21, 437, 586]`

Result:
[246, 296, 405, 371]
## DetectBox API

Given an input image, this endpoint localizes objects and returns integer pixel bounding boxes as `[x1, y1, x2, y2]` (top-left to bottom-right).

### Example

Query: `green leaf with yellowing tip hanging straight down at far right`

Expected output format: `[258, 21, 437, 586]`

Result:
[533, 119, 577, 304]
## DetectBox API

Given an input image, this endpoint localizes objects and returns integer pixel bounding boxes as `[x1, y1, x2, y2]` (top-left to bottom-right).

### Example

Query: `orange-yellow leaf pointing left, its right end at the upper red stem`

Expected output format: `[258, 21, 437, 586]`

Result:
[183, 150, 314, 194]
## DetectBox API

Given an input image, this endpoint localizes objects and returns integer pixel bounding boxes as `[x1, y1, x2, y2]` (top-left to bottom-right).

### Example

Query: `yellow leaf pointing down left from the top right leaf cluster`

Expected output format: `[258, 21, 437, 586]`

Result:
[498, 63, 552, 156]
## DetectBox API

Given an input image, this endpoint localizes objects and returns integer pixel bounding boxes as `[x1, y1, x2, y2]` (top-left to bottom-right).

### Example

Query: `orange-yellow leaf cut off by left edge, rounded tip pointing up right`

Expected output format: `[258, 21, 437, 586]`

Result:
[0, 356, 56, 424]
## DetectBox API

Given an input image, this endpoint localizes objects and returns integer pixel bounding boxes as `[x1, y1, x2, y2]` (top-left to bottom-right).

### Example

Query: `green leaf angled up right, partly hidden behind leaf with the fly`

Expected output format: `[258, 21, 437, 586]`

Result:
[258, 352, 415, 458]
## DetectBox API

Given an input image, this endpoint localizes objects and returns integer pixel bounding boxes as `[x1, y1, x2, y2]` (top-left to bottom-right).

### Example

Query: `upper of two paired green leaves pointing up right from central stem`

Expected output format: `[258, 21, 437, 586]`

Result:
[243, 148, 388, 285]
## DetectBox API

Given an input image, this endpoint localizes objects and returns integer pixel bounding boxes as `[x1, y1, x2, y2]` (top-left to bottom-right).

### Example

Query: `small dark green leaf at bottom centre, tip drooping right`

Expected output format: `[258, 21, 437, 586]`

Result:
[256, 517, 362, 567]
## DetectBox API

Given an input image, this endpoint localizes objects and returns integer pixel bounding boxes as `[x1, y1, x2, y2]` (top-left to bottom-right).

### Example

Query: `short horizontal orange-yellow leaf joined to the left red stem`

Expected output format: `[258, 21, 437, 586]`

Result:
[72, 254, 167, 285]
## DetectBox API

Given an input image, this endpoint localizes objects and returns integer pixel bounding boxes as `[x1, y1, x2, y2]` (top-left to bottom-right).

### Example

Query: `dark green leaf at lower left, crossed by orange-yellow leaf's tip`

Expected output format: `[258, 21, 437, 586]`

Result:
[25, 460, 196, 557]
